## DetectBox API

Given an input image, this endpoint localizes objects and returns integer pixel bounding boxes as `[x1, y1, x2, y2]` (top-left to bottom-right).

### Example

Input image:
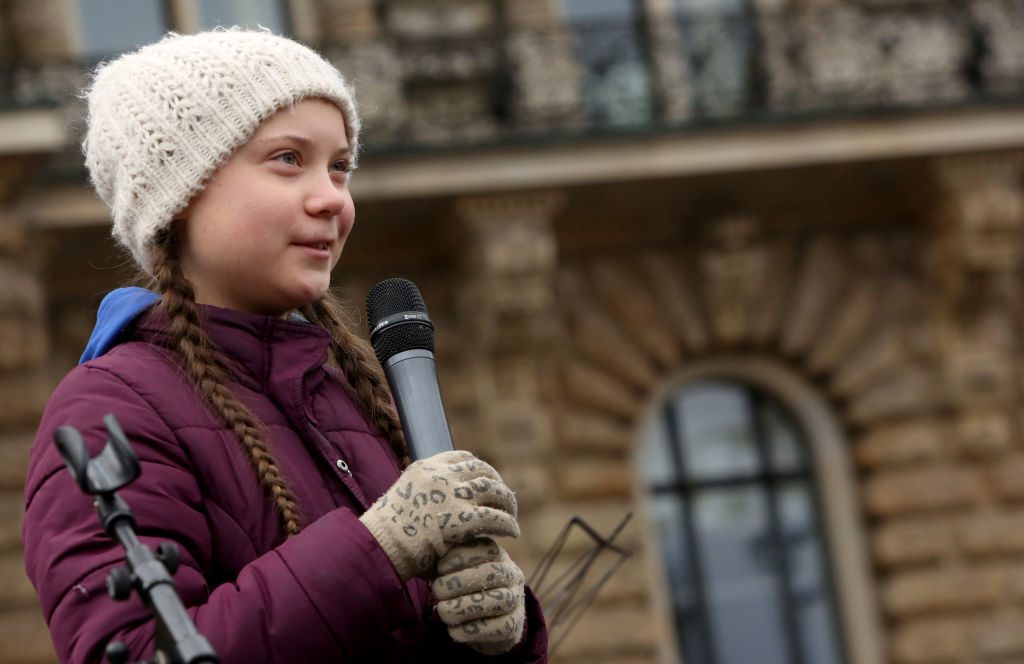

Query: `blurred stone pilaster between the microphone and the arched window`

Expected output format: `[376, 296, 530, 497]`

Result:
[458, 194, 561, 575]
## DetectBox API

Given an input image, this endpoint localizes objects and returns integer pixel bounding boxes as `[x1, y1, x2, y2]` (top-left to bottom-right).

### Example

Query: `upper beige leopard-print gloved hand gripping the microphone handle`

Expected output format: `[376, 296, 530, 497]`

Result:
[359, 451, 519, 581]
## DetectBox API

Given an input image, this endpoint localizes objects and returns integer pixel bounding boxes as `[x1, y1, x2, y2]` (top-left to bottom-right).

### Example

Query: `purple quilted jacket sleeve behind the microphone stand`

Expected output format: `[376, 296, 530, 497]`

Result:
[24, 365, 422, 664]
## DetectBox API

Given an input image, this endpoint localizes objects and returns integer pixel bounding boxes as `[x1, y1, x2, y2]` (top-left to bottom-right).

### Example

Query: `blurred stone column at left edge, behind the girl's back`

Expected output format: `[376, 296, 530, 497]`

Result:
[0, 179, 56, 662]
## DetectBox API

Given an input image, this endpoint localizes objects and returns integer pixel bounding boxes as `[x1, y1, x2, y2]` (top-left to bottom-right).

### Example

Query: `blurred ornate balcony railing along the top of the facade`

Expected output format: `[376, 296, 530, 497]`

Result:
[0, 0, 1024, 152]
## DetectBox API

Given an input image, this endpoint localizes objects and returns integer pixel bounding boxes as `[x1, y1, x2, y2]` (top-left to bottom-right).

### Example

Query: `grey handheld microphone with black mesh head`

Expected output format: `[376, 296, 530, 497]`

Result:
[367, 279, 455, 461]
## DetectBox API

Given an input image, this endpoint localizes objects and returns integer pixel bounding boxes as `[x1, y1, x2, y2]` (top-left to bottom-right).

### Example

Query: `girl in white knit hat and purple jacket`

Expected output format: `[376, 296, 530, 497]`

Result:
[24, 29, 547, 664]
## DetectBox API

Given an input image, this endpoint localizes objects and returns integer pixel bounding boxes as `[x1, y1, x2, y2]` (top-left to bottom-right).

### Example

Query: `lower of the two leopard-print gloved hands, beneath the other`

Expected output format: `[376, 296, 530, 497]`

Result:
[430, 537, 526, 655]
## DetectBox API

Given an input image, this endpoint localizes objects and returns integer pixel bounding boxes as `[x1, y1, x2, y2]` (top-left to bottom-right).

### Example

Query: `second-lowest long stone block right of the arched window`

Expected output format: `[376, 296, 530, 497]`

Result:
[883, 567, 1011, 617]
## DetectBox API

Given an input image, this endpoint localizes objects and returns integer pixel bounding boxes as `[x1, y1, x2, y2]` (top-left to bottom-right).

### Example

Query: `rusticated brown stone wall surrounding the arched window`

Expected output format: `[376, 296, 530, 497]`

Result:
[553, 158, 1024, 664]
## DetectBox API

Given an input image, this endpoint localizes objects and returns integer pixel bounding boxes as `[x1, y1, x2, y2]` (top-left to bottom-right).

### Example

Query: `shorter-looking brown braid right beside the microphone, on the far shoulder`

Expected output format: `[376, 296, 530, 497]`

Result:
[301, 293, 410, 467]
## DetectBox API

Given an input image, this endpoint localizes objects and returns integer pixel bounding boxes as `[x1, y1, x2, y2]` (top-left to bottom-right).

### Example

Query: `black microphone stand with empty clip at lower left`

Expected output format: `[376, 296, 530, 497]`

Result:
[53, 415, 219, 664]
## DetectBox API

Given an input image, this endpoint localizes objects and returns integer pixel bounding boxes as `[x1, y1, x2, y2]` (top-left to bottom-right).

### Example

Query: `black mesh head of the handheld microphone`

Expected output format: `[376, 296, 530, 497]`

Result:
[367, 279, 434, 365]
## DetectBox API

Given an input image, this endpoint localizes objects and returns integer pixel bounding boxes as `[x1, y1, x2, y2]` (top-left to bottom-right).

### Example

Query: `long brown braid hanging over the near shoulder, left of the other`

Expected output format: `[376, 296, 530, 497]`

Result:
[153, 234, 301, 537]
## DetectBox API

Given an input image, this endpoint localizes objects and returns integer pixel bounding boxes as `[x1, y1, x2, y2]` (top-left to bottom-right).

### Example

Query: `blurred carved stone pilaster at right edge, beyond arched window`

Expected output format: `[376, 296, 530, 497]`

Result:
[930, 154, 1024, 463]
